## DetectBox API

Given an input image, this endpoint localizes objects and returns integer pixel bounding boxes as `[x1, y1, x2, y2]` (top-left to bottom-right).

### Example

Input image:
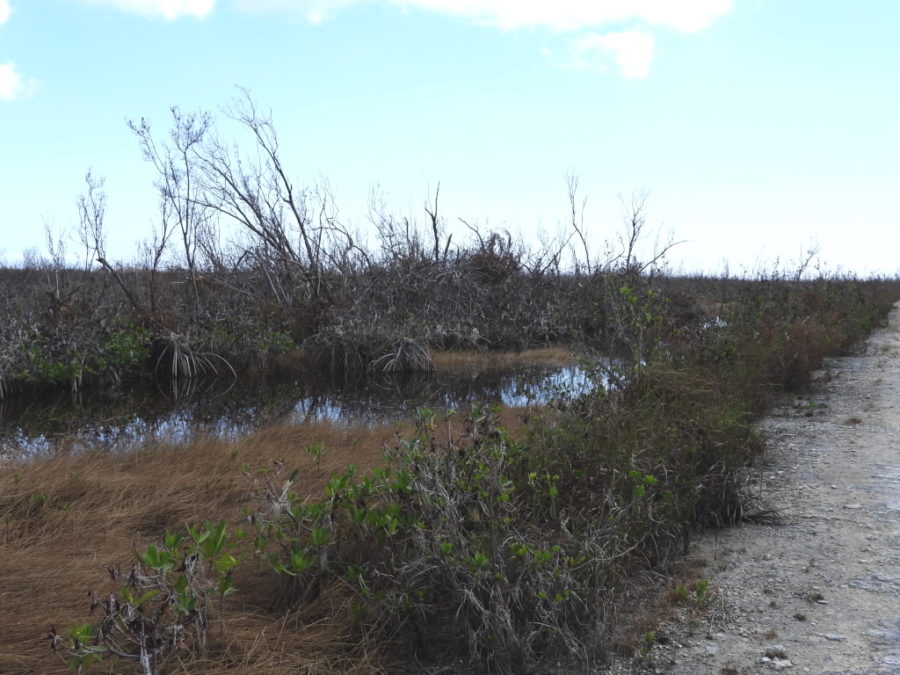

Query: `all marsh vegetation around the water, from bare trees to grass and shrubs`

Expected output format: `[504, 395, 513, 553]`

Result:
[0, 100, 900, 673]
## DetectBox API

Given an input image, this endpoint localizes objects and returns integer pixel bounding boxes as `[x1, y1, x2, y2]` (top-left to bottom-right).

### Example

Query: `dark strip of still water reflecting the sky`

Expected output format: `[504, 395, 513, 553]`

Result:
[0, 366, 592, 457]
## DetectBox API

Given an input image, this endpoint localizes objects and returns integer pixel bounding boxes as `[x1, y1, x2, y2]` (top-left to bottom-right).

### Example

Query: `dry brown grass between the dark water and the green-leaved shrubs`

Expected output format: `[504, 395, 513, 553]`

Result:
[0, 410, 536, 675]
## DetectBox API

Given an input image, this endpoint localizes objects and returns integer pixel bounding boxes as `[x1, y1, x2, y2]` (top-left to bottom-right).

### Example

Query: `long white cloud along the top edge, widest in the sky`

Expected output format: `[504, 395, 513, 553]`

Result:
[225, 0, 733, 33]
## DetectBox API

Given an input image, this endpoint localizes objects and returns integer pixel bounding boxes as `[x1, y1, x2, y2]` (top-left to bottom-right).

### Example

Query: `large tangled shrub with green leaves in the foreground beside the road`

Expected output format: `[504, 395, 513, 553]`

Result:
[246, 408, 624, 672]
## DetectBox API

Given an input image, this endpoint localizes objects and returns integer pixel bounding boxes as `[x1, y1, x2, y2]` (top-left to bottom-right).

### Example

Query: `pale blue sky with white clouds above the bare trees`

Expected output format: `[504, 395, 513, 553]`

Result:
[0, 0, 900, 274]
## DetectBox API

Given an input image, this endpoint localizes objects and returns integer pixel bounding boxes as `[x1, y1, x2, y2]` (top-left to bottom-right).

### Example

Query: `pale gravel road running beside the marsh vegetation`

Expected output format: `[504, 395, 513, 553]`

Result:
[605, 303, 900, 675]
